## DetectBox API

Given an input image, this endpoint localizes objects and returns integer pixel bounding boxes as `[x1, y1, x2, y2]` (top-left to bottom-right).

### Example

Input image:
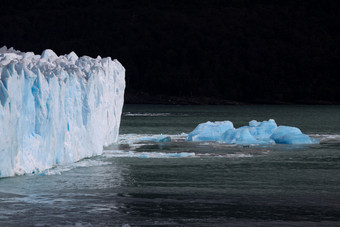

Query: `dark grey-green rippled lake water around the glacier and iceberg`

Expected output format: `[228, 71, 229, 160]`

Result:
[0, 105, 340, 226]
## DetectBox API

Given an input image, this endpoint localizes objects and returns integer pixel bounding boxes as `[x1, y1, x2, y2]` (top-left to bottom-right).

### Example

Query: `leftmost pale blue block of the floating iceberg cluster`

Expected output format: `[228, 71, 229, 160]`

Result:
[187, 121, 234, 141]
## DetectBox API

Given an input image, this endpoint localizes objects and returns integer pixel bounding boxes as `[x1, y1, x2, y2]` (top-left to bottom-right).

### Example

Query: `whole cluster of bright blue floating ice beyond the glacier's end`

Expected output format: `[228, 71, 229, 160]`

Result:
[187, 119, 319, 145]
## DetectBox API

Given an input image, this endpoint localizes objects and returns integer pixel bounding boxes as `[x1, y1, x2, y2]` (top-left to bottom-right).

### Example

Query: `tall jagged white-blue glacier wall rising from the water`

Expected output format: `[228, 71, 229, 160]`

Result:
[0, 46, 125, 177]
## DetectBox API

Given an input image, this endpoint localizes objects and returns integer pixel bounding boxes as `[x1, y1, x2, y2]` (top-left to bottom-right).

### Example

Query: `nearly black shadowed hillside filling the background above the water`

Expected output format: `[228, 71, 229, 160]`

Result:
[0, 0, 340, 104]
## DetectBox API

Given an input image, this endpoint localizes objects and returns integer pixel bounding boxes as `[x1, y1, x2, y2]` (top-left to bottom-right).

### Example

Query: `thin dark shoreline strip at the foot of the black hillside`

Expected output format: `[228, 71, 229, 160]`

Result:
[124, 93, 340, 105]
